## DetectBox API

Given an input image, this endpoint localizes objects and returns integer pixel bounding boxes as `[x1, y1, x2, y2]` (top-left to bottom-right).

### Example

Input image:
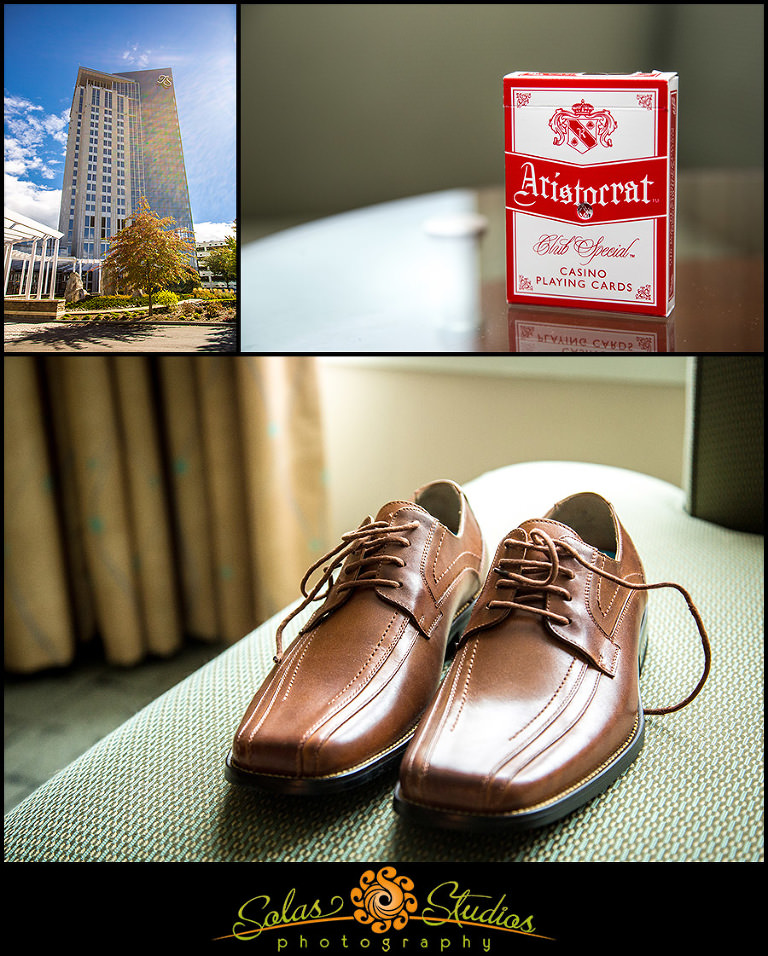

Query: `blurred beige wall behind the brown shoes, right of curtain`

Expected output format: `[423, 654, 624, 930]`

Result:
[319, 357, 686, 542]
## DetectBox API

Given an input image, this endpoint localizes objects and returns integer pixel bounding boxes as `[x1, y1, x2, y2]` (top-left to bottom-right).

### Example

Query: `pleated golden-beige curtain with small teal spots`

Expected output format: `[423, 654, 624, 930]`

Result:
[4, 356, 327, 673]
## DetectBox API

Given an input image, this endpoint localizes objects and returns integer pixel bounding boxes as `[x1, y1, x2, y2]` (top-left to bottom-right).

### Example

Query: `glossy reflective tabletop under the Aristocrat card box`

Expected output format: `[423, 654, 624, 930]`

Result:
[241, 173, 763, 354]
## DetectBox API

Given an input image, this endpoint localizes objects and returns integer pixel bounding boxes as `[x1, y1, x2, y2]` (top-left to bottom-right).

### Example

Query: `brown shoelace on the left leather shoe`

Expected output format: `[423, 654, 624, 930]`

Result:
[273, 520, 419, 664]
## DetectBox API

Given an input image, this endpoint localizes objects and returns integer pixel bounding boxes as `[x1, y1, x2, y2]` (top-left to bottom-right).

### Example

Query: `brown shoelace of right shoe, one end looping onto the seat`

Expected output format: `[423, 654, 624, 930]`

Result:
[488, 529, 712, 714]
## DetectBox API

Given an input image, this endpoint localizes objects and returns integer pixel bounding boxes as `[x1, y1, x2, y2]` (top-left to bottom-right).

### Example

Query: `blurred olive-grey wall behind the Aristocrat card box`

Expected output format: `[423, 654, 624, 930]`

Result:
[239, 3, 764, 230]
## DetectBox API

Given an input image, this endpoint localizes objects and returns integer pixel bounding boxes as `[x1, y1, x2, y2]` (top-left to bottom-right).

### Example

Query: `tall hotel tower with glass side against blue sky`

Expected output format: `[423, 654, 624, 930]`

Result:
[59, 67, 197, 292]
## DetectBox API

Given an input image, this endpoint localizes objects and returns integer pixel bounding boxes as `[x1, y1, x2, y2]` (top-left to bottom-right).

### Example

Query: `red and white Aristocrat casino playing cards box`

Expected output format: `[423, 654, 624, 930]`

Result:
[504, 72, 678, 316]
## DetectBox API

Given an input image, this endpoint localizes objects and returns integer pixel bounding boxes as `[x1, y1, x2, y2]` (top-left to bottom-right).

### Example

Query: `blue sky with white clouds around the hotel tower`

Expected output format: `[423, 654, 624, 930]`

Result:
[3, 3, 237, 240]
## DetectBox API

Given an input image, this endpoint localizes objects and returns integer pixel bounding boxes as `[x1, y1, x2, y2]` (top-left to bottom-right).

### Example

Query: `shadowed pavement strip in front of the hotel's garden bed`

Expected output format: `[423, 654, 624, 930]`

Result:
[4, 321, 237, 353]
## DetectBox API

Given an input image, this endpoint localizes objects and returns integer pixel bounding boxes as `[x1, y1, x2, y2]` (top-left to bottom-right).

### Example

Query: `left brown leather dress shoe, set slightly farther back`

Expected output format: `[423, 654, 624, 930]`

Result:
[226, 481, 485, 794]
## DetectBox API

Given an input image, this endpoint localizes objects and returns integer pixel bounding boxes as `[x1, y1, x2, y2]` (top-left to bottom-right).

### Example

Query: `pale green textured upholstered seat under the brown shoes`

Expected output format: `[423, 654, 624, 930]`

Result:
[5, 462, 763, 863]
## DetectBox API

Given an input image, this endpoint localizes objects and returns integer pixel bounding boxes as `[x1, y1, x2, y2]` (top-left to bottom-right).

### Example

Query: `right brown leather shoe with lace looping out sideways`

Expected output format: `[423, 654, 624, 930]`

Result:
[395, 493, 709, 830]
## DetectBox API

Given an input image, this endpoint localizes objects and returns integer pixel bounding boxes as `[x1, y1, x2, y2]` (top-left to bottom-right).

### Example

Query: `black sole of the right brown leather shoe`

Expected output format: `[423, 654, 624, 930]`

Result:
[393, 609, 648, 833]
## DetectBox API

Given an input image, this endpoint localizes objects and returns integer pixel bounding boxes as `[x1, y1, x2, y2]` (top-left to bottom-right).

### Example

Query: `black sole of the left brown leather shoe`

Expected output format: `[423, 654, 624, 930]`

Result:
[224, 599, 474, 796]
